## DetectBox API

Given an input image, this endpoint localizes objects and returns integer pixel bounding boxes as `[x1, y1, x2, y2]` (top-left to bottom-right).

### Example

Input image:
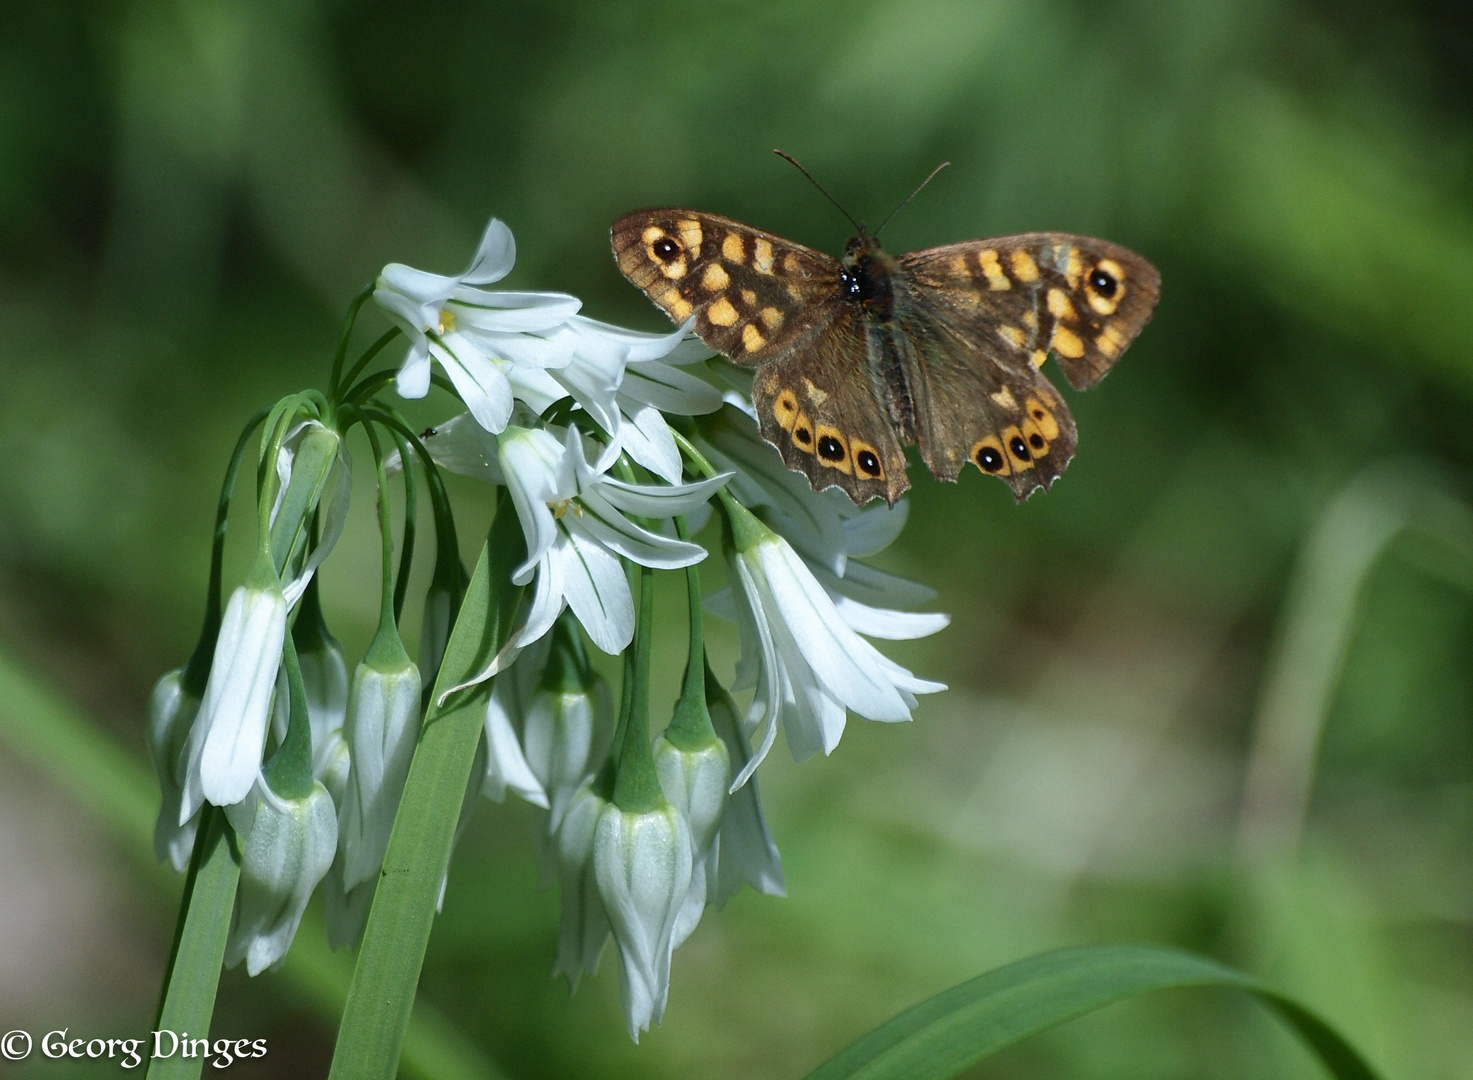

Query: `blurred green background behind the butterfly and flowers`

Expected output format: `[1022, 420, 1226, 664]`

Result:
[0, 0, 1473, 1080]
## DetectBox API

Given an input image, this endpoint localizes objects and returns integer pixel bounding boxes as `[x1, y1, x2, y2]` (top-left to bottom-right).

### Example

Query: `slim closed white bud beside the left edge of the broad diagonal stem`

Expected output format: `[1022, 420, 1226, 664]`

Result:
[342, 631, 420, 890]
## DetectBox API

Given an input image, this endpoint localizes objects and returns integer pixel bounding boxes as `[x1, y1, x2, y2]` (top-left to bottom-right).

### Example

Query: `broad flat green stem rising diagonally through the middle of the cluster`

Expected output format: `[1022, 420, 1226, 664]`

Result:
[330, 489, 526, 1080]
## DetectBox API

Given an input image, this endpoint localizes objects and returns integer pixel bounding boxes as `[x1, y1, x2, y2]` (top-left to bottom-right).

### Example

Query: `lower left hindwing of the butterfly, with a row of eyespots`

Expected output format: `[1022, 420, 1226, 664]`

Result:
[751, 304, 910, 505]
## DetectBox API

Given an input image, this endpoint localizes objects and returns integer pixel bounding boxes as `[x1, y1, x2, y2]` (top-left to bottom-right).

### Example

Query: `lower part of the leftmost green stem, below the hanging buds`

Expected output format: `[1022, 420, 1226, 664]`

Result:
[147, 803, 240, 1080]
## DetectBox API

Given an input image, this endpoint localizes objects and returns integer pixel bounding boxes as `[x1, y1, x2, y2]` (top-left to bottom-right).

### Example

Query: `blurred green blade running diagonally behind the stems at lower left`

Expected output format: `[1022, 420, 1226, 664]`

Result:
[0, 653, 498, 1080]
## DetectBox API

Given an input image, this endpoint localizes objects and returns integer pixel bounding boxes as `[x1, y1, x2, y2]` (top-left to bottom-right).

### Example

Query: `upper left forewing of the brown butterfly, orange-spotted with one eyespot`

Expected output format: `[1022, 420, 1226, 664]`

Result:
[611, 208, 840, 367]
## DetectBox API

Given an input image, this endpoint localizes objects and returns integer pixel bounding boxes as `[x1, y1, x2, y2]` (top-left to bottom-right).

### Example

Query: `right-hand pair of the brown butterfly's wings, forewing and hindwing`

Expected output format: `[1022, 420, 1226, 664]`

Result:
[896, 233, 1159, 501]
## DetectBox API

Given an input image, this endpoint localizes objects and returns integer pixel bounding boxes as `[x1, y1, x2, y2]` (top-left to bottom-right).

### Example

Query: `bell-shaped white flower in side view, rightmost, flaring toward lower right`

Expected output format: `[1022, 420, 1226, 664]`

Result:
[723, 499, 946, 785]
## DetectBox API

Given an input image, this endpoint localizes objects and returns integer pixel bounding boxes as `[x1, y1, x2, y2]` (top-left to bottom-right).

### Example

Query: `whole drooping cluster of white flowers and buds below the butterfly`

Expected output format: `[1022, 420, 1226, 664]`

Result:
[149, 220, 947, 1039]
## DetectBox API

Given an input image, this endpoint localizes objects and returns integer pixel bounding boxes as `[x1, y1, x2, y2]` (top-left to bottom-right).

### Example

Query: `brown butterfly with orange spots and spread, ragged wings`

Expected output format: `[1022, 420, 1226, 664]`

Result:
[611, 204, 1161, 505]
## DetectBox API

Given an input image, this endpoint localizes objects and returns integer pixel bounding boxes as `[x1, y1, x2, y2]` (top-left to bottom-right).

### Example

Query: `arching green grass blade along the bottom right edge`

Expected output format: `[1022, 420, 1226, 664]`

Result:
[807, 946, 1377, 1080]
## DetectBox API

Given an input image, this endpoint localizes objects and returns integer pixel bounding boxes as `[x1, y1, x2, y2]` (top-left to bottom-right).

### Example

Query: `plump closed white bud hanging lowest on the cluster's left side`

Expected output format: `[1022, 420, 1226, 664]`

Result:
[225, 782, 337, 975]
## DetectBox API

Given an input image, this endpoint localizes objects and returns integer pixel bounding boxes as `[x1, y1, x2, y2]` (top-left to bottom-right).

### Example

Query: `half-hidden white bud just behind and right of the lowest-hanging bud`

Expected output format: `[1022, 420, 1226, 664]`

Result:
[654, 735, 732, 949]
